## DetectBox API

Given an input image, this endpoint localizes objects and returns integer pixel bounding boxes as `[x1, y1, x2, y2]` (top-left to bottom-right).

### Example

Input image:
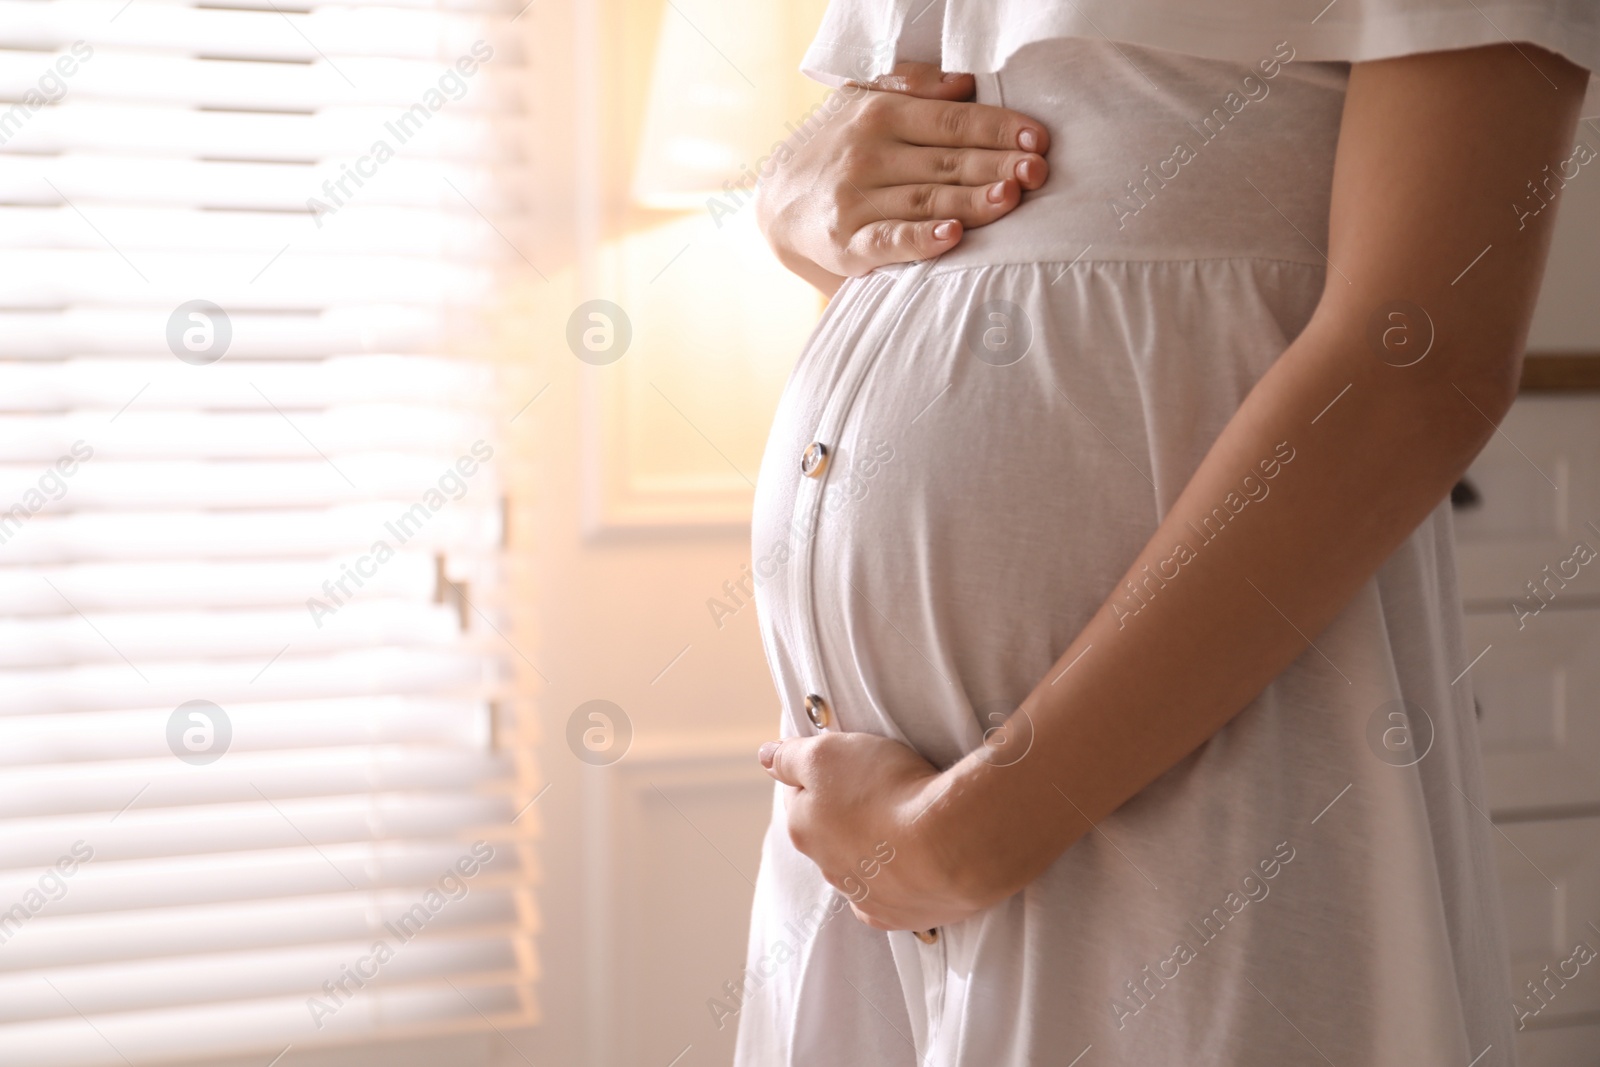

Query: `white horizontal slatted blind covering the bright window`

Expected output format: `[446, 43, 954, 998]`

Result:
[0, 0, 539, 1067]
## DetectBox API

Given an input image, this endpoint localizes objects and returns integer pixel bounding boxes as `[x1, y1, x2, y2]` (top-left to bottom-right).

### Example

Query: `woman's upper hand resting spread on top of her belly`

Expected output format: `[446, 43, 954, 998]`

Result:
[755, 62, 1050, 296]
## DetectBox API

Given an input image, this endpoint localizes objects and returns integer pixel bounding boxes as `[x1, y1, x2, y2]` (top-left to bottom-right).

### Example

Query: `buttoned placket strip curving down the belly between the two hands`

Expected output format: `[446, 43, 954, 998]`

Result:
[789, 259, 934, 733]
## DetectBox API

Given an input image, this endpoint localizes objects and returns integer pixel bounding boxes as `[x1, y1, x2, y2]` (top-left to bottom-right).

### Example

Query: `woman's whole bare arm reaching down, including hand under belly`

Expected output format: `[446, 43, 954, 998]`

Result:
[763, 45, 1587, 929]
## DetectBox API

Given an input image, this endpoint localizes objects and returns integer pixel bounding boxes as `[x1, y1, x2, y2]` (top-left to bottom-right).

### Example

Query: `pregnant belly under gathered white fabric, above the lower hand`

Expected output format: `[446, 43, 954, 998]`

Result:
[754, 261, 1322, 765]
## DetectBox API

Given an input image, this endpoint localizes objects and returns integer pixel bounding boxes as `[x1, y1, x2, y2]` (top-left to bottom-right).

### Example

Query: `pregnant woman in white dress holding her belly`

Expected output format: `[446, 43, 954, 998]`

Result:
[725, 0, 1600, 1067]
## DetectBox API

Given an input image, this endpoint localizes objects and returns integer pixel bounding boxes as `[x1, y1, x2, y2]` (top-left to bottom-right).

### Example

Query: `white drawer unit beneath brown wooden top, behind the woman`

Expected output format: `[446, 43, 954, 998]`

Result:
[1454, 379, 1600, 1067]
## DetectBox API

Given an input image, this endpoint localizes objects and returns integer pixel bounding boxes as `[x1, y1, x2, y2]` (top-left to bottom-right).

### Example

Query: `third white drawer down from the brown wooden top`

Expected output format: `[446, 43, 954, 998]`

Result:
[1494, 817, 1600, 1030]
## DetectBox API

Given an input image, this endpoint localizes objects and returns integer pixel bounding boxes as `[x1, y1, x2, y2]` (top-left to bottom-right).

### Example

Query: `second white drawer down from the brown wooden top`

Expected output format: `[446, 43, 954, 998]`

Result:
[1466, 608, 1600, 816]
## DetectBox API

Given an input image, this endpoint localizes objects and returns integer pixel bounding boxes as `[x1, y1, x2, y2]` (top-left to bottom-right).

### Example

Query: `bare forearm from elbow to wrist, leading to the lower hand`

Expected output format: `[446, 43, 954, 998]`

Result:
[936, 307, 1509, 904]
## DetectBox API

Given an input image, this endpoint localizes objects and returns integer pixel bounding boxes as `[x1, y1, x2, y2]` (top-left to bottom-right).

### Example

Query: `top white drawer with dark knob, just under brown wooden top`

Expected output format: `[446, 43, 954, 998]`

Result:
[1454, 394, 1600, 611]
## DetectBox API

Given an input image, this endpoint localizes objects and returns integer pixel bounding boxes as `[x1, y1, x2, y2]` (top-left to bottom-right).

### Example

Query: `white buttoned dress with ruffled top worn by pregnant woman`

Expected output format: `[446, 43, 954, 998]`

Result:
[732, 0, 1597, 1067]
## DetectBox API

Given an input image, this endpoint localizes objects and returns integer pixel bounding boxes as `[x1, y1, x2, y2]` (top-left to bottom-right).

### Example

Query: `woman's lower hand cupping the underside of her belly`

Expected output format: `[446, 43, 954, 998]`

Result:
[760, 733, 978, 929]
